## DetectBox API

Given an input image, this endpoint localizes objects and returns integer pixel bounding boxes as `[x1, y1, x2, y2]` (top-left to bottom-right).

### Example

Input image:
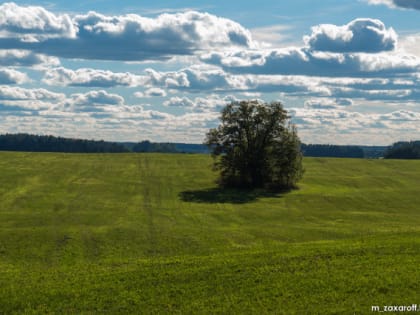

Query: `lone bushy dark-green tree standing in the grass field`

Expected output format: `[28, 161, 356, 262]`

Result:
[205, 101, 303, 189]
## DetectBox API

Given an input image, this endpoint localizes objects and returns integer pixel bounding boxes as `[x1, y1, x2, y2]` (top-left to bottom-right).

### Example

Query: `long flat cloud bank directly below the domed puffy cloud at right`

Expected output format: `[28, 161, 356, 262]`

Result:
[202, 48, 420, 77]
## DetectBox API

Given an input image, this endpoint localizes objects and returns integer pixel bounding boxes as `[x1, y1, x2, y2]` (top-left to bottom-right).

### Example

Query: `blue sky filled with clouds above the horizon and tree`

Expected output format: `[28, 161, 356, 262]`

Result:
[0, 0, 420, 145]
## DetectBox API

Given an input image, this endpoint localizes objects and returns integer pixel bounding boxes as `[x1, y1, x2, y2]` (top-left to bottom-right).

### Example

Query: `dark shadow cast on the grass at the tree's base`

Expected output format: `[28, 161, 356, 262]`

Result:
[179, 187, 287, 203]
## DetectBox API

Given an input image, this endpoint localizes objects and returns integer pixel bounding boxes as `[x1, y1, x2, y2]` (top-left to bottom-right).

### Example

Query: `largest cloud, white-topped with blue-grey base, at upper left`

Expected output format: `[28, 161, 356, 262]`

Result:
[0, 3, 255, 61]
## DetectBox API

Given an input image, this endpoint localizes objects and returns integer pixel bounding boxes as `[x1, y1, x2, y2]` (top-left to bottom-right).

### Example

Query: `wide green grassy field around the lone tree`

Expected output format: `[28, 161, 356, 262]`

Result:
[0, 152, 420, 314]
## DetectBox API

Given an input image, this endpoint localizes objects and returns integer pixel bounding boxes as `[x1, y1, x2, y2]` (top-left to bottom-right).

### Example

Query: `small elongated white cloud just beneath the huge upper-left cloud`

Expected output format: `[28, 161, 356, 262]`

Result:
[43, 67, 146, 88]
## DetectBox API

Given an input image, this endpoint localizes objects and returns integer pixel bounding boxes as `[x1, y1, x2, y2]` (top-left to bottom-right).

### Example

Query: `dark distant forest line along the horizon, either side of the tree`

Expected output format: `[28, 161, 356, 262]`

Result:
[0, 133, 414, 159]
